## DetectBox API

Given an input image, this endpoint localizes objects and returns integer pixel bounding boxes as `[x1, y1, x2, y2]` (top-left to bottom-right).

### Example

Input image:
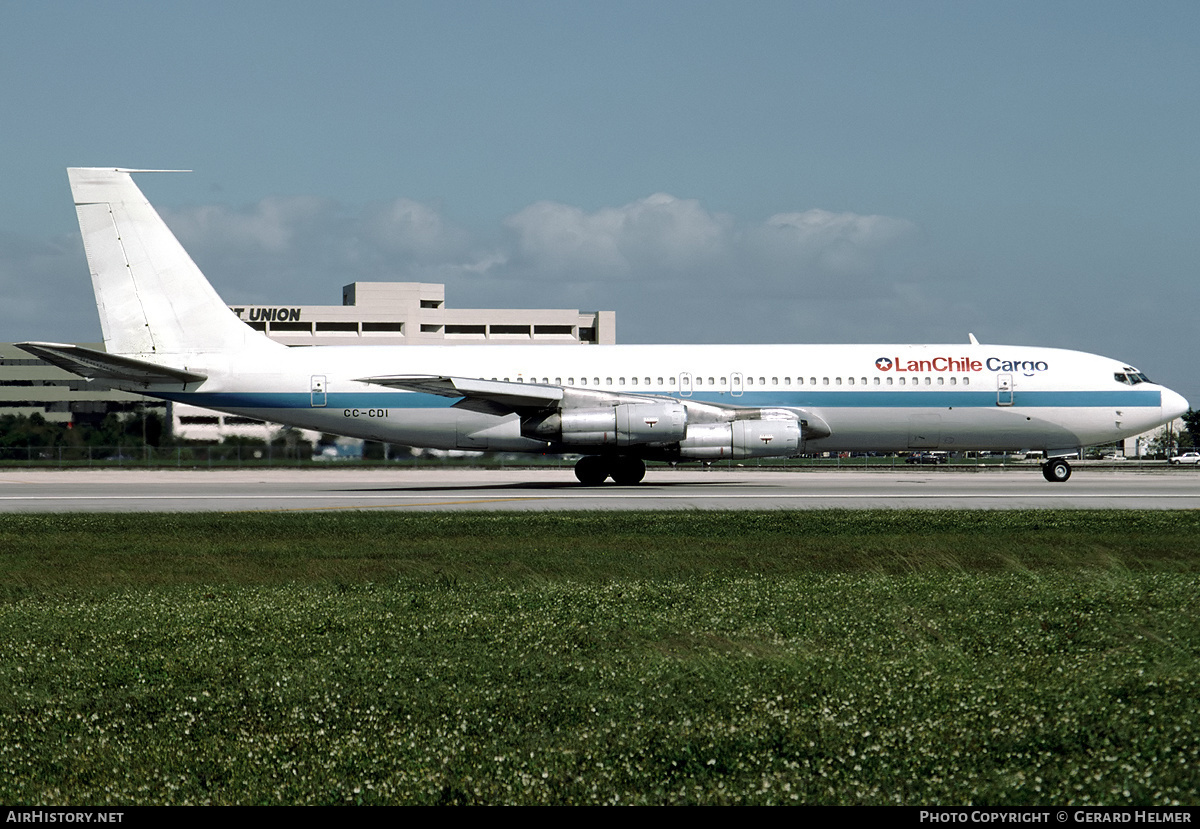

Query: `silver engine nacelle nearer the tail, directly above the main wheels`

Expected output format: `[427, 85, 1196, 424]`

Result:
[523, 401, 688, 446]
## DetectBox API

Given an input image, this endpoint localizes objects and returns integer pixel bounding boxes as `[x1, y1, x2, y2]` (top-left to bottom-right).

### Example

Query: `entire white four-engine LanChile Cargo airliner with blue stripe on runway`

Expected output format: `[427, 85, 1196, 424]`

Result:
[20, 168, 1188, 485]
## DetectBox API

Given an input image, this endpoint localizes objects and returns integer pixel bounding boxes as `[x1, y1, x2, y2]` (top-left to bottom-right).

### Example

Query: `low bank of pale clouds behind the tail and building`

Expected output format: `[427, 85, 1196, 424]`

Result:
[0, 193, 934, 342]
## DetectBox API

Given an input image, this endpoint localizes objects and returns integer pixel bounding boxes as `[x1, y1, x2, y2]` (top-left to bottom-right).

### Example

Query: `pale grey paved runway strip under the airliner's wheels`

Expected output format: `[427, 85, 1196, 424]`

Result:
[0, 465, 1200, 512]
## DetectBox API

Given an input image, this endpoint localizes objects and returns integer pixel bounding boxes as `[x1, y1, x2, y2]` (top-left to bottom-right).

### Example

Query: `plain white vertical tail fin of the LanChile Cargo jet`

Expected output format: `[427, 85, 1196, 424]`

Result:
[67, 167, 282, 358]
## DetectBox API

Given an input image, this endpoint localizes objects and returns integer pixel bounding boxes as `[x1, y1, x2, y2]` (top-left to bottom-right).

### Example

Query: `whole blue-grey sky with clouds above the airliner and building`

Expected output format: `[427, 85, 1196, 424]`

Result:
[0, 0, 1200, 407]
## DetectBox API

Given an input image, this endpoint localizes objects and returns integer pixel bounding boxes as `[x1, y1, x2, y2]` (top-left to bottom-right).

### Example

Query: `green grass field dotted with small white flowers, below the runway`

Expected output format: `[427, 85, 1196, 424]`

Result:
[0, 511, 1200, 805]
